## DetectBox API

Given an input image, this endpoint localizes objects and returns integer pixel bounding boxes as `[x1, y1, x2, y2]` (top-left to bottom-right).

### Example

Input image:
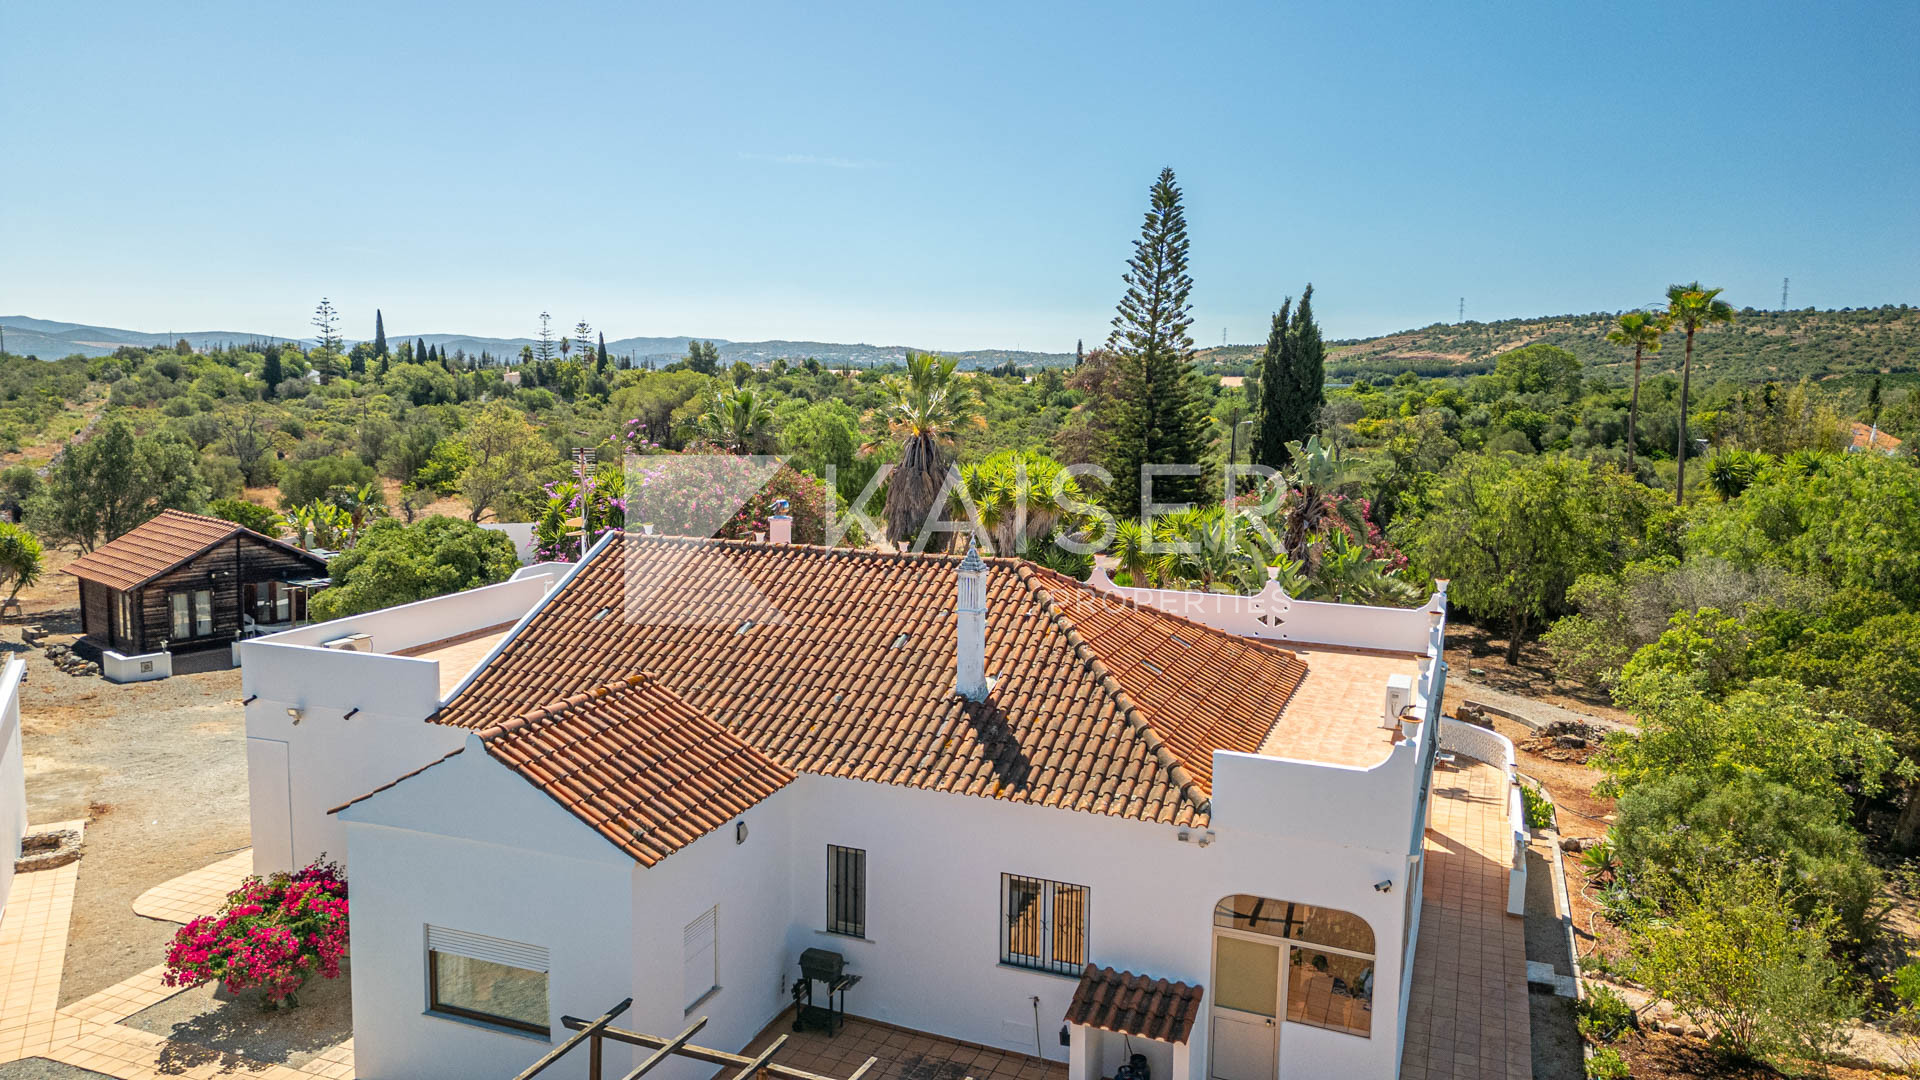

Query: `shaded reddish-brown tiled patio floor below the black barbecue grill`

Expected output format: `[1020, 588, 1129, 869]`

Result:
[739, 1011, 1068, 1080]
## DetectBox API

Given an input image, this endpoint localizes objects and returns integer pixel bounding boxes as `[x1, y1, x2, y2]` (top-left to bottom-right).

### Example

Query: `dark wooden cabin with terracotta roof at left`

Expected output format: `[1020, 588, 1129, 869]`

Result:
[65, 509, 326, 655]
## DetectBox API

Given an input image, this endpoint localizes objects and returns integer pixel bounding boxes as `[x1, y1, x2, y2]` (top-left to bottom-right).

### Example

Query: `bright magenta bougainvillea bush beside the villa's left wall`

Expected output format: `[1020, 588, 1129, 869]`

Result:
[165, 859, 348, 1009]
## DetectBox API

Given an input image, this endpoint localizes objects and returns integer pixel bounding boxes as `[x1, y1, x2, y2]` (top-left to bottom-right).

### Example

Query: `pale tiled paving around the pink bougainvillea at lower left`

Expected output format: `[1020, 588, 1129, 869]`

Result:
[0, 834, 353, 1080]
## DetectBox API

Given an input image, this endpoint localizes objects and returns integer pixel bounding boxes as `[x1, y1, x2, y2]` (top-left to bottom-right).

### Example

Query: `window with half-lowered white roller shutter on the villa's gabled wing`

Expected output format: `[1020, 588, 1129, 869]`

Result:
[426, 926, 553, 1038]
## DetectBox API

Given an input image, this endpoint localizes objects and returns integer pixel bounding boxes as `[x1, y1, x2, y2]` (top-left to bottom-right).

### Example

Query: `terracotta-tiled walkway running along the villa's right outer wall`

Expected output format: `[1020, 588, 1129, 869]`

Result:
[1400, 757, 1534, 1080]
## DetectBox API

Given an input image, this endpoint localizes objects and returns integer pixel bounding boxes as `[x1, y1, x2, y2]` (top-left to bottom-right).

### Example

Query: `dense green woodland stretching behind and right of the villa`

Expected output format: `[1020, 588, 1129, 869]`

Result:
[0, 171, 1920, 1061]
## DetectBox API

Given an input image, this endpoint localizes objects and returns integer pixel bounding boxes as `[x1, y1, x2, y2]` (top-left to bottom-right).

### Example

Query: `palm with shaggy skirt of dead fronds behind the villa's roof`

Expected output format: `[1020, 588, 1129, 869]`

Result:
[868, 352, 985, 544]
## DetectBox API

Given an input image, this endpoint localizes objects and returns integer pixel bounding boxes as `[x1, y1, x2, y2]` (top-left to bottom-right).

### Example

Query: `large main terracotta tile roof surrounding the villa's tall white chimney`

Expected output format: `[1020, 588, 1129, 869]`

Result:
[436, 536, 1306, 824]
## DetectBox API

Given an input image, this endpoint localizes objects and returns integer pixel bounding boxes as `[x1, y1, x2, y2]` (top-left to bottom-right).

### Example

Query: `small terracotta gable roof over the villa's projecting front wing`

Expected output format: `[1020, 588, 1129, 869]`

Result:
[336, 675, 793, 867]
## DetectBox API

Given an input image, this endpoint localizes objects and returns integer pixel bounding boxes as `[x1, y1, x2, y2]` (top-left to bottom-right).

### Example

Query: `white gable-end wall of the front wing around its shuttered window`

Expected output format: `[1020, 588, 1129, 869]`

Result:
[336, 740, 641, 1080]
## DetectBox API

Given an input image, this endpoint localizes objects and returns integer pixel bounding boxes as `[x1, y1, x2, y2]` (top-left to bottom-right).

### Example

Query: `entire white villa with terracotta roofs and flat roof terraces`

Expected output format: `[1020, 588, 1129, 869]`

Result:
[238, 530, 1526, 1080]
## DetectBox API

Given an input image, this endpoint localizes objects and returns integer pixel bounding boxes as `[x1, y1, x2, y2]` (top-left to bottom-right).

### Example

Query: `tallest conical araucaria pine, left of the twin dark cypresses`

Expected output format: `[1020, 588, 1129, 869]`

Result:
[1100, 169, 1206, 513]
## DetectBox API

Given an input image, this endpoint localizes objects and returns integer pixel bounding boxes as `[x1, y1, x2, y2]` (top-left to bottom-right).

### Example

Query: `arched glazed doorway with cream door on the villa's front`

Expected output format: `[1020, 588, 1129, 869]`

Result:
[1208, 894, 1373, 1080]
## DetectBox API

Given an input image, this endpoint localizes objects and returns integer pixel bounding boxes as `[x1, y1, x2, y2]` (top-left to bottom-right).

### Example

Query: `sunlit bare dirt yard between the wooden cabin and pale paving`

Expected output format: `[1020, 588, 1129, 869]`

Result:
[11, 599, 250, 1005]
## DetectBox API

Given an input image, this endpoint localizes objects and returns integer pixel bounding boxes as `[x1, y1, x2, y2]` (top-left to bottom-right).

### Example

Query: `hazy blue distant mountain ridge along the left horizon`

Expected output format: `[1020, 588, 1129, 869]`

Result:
[0, 315, 1073, 367]
